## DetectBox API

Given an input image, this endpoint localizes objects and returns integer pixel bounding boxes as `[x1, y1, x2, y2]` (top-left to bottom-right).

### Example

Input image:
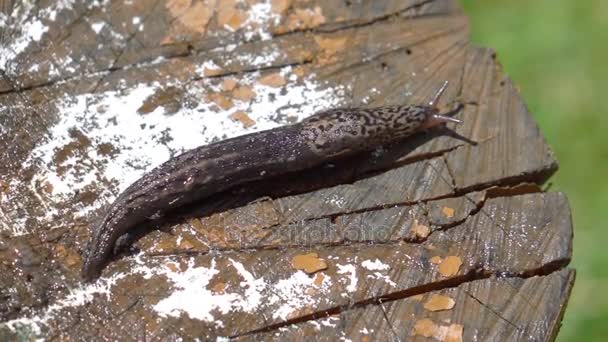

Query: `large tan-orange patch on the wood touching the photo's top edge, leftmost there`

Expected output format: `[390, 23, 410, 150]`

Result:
[161, 0, 217, 44]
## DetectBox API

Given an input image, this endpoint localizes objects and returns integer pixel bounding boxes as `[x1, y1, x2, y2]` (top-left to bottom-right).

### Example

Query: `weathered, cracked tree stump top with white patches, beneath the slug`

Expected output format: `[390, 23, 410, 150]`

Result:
[0, 0, 574, 341]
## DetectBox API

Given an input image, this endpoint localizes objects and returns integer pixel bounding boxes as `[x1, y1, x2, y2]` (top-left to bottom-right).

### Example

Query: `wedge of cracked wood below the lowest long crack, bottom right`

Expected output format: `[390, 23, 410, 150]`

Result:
[237, 269, 574, 341]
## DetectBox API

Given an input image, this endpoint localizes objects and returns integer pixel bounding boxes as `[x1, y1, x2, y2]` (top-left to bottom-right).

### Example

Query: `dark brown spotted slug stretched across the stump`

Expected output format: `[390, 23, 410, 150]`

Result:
[82, 82, 462, 281]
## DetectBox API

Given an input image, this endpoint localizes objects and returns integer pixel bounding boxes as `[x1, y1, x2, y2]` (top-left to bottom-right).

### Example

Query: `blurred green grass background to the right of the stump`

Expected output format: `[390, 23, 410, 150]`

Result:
[462, 0, 608, 341]
